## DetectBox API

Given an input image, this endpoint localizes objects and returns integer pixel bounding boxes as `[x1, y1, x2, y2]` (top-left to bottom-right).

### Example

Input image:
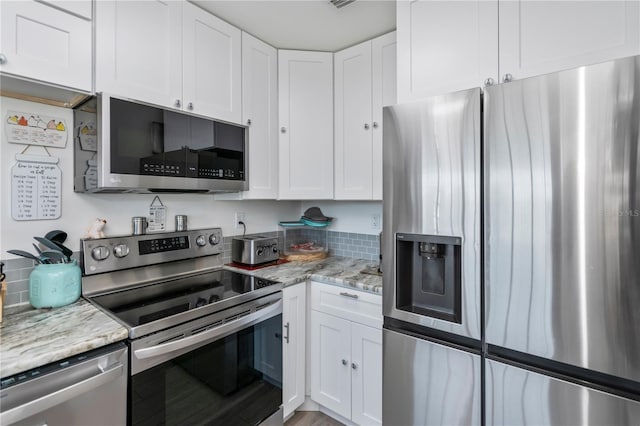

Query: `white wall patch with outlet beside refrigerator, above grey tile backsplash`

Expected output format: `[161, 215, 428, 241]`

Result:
[302, 201, 382, 235]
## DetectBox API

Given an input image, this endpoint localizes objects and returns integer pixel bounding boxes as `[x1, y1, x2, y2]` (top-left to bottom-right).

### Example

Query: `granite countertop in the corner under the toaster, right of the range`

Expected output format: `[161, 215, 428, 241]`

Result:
[225, 256, 382, 295]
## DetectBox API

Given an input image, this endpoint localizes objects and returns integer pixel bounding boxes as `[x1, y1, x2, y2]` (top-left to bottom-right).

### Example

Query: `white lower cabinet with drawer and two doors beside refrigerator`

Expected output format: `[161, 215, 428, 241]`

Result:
[309, 283, 382, 425]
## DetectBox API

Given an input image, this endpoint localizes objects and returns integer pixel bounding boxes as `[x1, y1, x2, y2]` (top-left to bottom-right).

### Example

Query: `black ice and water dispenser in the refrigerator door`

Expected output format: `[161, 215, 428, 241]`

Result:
[396, 233, 462, 323]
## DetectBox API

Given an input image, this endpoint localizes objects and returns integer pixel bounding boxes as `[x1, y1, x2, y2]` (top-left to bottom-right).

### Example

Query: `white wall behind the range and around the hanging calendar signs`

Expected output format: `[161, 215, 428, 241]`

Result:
[0, 97, 301, 259]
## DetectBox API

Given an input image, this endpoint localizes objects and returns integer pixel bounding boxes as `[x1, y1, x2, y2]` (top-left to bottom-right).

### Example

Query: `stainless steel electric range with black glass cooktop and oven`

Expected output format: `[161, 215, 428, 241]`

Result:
[81, 228, 282, 426]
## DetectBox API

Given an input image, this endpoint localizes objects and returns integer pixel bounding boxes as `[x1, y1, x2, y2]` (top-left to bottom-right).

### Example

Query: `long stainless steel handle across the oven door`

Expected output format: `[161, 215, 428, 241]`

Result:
[133, 300, 282, 359]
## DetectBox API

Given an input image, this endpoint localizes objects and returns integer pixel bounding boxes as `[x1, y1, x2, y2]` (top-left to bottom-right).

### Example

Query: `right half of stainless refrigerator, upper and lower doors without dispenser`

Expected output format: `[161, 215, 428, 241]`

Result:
[484, 57, 640, 425]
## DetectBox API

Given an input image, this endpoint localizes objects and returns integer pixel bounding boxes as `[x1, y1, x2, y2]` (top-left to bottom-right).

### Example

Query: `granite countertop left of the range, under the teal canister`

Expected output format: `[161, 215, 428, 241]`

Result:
[0, 298, 129, 377]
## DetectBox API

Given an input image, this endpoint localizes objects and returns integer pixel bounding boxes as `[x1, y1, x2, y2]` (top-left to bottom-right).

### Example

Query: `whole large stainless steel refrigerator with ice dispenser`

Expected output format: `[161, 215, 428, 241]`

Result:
[383, 57, 640, 425]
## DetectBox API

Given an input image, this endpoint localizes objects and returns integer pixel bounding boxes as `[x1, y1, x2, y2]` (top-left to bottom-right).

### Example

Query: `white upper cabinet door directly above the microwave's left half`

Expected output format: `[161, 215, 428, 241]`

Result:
[95, 0, 182, 107]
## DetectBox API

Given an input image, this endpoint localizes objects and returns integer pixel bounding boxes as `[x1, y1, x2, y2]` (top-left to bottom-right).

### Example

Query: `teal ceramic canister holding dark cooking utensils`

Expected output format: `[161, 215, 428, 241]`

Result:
[29, 259, 82, 308]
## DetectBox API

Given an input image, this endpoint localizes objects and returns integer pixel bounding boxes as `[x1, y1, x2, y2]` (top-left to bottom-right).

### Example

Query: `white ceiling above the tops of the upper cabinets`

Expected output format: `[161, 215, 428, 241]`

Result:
[192, 0, 396, 52]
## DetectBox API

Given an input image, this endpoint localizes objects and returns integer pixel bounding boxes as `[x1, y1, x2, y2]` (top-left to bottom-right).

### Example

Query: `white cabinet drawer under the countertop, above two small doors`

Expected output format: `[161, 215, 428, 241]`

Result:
[311, 281, 382, 328]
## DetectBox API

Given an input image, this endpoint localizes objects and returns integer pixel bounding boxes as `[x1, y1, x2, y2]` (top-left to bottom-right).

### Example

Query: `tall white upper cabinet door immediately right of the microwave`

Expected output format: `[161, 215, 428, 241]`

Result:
[242, 33, 278, 199]
